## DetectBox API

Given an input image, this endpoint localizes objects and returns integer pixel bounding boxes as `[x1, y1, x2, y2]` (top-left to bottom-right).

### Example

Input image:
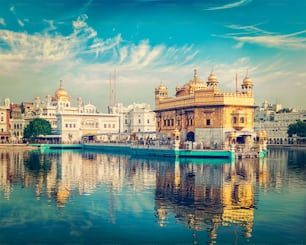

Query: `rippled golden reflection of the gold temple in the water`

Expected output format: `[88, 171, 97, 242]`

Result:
[156, 159, 259, 243]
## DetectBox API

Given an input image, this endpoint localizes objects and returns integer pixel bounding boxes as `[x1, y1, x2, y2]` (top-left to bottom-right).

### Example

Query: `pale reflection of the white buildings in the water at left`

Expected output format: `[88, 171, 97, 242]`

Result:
[0, 149, 156, 207]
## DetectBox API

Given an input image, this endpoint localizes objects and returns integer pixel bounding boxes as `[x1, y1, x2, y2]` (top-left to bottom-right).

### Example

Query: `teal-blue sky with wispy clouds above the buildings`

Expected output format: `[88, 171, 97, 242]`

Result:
[0, 0, 306, 112]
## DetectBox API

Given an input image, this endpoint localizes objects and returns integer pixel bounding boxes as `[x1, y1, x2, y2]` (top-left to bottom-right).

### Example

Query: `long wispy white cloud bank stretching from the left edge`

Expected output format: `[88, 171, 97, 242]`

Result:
[0, 10, 199, 79]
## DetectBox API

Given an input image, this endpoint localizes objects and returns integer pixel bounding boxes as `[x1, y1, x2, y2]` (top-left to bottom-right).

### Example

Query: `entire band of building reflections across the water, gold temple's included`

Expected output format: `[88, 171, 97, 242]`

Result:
[0, 146, 306, 244]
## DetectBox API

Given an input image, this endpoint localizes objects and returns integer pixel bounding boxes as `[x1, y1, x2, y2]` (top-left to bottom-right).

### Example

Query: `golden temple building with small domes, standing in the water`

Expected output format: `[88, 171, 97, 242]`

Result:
[155, 70, 255, 143]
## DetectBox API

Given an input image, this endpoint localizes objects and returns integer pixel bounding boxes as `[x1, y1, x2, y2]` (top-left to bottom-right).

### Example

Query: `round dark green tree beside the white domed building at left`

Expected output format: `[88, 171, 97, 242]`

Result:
[23, 118, 51, 139]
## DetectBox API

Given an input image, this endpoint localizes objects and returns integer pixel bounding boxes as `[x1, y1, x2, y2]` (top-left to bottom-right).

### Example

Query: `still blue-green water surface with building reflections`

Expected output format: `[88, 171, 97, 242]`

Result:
[0, 146, 306, 244]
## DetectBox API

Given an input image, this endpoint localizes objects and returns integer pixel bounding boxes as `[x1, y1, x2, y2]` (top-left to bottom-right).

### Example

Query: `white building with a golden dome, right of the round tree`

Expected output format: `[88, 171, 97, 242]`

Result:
[25, 81, 119, 143]
